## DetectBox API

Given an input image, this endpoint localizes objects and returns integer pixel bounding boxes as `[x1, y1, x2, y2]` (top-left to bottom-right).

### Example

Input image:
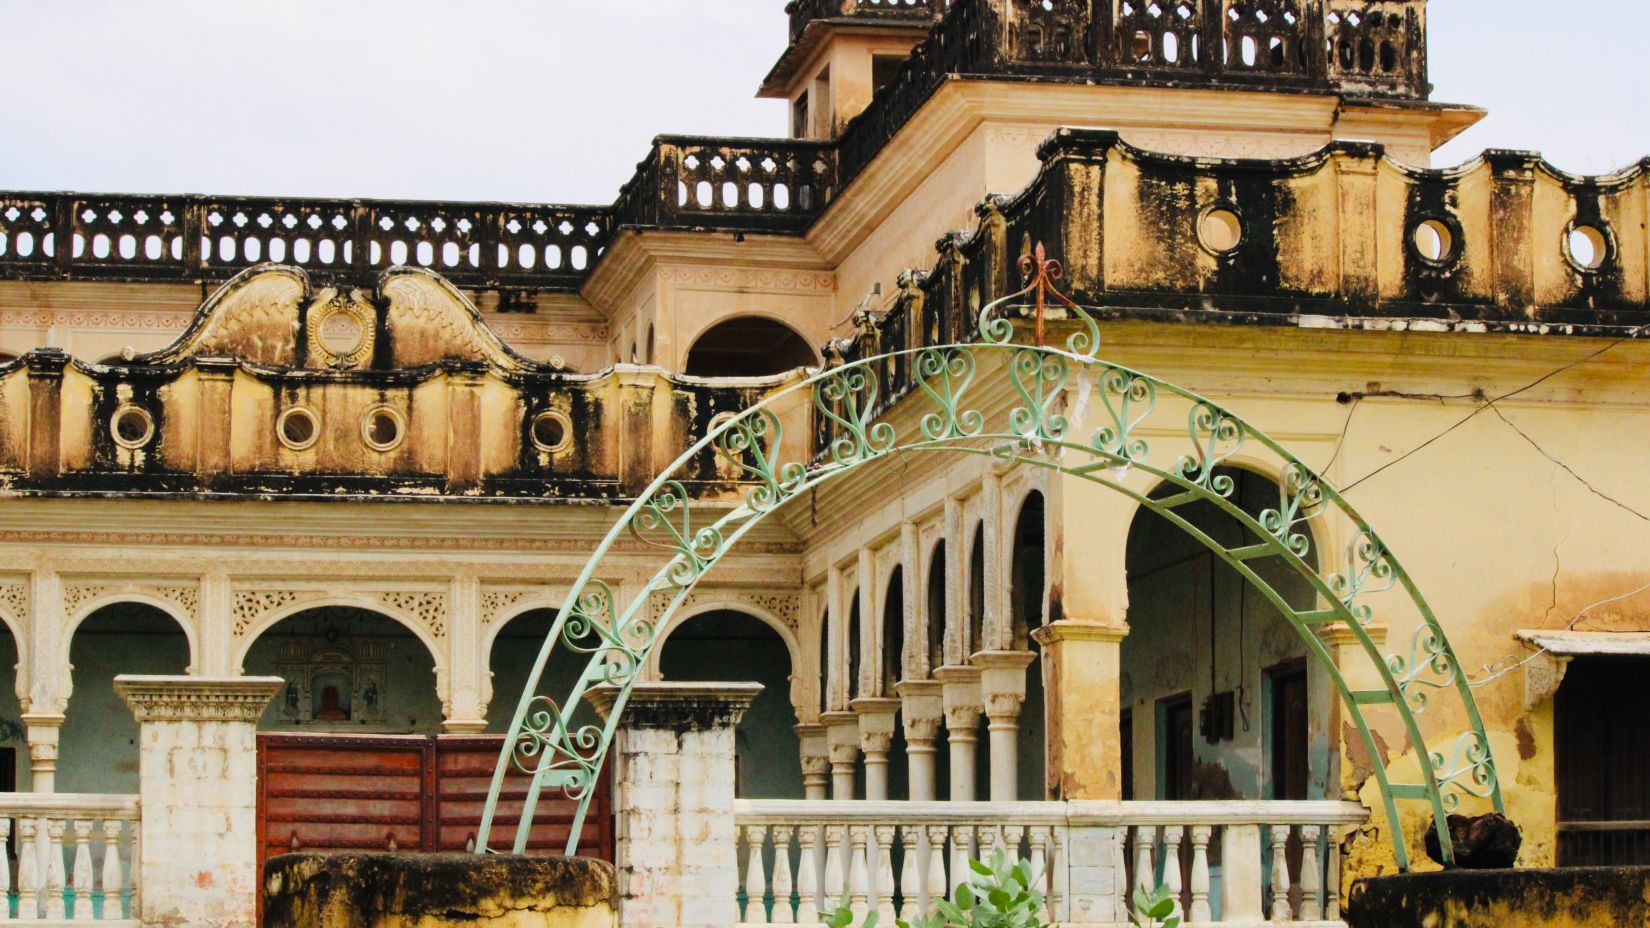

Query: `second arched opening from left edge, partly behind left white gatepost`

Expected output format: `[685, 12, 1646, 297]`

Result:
[56, 603, 190, 793]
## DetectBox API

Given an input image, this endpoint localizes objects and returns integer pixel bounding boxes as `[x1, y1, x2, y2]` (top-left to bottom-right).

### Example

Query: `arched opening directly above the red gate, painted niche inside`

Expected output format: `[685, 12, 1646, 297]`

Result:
[241, 606, 442, 735]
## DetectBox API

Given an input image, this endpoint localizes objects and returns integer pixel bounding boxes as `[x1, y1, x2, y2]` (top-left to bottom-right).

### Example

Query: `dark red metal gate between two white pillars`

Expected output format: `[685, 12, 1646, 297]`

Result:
[257, 733, 614, 872]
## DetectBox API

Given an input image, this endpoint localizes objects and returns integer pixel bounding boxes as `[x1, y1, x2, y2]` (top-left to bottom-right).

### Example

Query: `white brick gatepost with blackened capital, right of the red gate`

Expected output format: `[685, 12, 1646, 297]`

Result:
[589, 682, 762, 928]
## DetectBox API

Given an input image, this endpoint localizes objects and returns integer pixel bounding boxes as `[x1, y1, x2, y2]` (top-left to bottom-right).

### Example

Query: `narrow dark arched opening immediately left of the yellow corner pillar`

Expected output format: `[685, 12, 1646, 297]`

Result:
[1008, 490, 1048, 799]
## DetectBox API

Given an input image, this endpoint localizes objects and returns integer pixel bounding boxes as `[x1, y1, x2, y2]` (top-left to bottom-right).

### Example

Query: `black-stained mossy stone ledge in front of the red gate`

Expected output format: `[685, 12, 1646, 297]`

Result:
[264, 854, 617, 928]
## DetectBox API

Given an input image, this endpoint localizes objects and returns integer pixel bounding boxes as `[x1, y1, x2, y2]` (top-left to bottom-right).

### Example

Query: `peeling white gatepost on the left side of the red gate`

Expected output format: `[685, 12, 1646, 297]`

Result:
[114, 675, 285, 928]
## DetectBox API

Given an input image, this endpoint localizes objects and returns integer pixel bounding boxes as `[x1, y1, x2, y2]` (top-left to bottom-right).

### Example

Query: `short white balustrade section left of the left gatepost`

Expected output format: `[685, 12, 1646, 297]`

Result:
[0, 793, 139, 925]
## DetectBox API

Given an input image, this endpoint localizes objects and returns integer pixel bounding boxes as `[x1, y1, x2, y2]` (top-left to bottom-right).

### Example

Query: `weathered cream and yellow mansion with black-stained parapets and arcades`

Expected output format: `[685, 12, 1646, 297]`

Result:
[0, 0, 1650, 925]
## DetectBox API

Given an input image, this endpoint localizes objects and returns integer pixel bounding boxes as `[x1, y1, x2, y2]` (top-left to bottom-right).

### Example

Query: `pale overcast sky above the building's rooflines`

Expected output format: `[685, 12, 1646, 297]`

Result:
[0, 0, 1650, 203]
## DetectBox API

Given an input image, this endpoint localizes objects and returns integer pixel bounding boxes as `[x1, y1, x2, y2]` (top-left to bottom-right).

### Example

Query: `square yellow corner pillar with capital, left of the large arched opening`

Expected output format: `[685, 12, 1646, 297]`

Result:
[1031, 621, 1129, 799]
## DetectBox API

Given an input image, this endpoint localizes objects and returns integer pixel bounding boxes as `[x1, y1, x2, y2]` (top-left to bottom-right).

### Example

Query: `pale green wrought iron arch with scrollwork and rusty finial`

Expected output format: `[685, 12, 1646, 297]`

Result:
[477, 248, 1505, 870]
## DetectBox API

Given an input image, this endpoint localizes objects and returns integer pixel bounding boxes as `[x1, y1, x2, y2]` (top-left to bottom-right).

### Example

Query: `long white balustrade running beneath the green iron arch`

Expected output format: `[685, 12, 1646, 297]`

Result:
[735, 799, 1368, 926]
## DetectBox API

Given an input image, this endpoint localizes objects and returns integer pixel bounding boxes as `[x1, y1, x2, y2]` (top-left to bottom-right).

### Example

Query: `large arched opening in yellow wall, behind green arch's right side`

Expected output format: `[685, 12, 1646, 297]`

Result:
[1120, 467, 1333, 799]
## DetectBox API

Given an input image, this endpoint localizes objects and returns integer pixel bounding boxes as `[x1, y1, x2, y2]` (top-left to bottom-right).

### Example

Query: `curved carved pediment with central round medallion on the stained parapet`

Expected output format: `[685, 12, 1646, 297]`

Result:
[135, 264, 540, 370]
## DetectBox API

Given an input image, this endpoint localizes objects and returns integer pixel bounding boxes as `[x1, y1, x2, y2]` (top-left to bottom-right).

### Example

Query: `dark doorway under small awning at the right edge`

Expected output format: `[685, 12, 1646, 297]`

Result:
[1553, 657, 1650, 867]
